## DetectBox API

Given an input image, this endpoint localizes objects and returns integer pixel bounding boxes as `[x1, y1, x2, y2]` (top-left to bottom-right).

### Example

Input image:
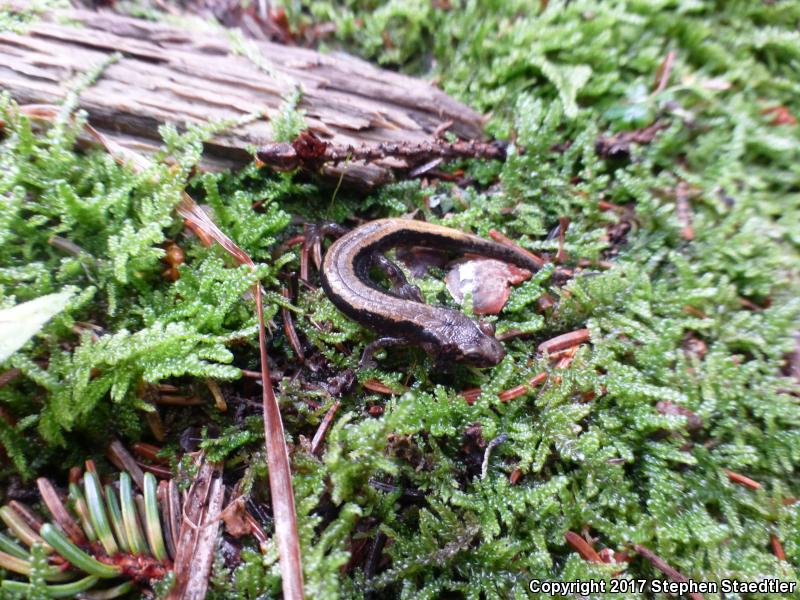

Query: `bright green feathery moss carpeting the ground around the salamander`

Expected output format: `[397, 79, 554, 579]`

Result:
[0, 0, 800, 598]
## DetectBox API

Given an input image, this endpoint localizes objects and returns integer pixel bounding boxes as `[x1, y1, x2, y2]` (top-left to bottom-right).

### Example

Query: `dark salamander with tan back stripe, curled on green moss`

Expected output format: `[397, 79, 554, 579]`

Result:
[321, 219, 539, 367]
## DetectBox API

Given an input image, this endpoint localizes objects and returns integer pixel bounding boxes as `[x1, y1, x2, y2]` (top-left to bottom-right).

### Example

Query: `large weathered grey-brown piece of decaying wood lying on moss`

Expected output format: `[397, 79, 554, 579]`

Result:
[0, 9, 482, 185]
